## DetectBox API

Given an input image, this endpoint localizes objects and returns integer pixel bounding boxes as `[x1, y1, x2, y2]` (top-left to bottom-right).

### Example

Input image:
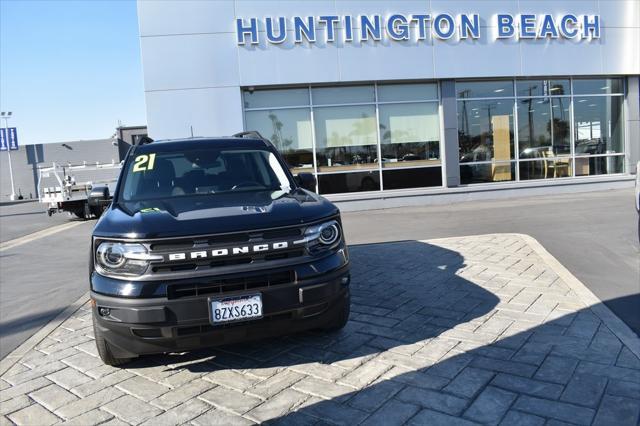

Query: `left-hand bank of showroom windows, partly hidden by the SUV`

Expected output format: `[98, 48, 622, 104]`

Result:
[243, 83, 442, 194]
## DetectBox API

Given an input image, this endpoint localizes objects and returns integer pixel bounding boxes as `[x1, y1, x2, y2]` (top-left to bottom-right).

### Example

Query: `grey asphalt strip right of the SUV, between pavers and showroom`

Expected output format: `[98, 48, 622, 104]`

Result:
[342, 188, 640, 335]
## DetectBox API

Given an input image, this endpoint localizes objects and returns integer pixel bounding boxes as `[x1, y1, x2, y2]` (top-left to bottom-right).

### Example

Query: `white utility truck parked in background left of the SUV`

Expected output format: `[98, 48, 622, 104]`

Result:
[38, 162, 122, 219]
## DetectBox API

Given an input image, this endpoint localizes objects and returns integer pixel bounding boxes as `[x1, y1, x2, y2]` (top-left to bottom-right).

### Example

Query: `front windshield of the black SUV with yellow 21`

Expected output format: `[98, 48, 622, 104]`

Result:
[121, 146, 290, 201]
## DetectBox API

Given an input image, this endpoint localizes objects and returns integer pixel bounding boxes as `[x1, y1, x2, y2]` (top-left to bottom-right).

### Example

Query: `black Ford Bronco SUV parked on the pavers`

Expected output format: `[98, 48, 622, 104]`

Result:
[90, 132, 350, 365]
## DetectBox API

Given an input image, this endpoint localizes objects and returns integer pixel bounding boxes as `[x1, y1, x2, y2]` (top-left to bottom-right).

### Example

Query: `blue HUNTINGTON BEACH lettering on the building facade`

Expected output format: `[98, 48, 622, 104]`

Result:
[236, 13, 600, 45]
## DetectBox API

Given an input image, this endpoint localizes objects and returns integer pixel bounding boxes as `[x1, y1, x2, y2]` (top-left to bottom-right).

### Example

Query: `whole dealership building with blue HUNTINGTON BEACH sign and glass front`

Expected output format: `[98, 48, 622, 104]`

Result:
[138, 0, 640, 204]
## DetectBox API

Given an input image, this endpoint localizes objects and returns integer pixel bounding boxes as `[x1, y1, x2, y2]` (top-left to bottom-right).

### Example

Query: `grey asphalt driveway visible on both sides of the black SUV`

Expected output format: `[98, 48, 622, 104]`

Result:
[0, 190, 640, 358]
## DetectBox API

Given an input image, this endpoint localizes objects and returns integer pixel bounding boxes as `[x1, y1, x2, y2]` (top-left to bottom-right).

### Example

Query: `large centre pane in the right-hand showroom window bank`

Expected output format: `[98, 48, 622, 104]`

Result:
[517, 98, 571, 159]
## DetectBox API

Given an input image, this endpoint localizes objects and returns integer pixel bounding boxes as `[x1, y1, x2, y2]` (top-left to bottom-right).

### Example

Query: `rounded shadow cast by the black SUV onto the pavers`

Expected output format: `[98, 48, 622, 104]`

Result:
[127, 241, 499, 372]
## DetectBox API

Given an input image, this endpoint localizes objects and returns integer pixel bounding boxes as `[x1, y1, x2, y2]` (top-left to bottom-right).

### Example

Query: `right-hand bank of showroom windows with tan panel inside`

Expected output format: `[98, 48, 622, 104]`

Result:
[456, 78, 624, 183]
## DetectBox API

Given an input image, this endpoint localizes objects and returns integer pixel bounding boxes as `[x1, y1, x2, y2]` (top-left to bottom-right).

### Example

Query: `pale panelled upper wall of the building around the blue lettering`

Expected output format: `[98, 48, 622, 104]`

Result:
[138, 0, 640, 138]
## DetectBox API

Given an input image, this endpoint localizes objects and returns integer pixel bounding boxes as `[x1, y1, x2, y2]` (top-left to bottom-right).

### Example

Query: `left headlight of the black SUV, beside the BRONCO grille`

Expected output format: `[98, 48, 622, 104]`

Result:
[96, 242, 162, 276]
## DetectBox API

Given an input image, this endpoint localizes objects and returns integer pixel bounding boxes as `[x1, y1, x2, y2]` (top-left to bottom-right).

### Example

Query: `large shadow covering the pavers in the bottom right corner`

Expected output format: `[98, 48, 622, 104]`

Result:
[270, 300, 640, 426]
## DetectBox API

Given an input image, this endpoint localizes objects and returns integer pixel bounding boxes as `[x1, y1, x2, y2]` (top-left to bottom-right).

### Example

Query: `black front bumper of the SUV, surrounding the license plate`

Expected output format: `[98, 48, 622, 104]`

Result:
[91, 263, 350, 358]
